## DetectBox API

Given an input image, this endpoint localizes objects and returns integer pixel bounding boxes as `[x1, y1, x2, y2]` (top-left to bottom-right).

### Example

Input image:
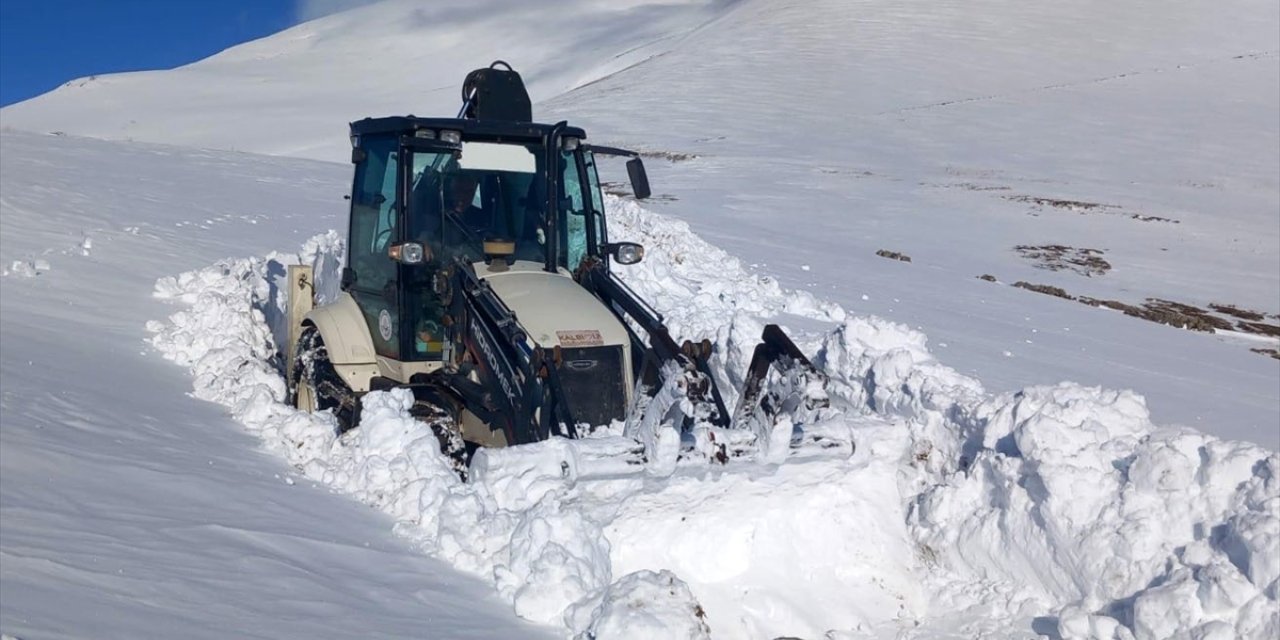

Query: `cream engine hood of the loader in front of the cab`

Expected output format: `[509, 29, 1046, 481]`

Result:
[475, 261, 628, 348]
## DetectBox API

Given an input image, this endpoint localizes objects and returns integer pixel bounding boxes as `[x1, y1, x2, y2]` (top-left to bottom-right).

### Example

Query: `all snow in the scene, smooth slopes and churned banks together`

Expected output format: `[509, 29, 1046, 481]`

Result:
[0, 0, 1280, 637]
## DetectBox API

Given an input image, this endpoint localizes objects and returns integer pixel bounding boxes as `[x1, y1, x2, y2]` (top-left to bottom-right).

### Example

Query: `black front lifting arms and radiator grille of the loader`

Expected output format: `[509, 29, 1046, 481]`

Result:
[415, 252, 824, 444]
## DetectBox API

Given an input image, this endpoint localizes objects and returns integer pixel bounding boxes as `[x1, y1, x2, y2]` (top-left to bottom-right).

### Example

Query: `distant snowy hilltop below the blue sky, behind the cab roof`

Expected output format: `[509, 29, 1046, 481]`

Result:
[0, 0, 713, 161]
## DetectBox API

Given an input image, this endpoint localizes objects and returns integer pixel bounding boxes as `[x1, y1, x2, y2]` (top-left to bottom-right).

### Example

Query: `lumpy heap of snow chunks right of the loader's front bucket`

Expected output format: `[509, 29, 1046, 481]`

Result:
[822, 319, 1280, 639]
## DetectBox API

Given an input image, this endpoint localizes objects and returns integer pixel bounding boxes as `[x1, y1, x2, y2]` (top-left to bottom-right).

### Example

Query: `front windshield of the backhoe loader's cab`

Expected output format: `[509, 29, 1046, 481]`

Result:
[407, 142, 547, 262]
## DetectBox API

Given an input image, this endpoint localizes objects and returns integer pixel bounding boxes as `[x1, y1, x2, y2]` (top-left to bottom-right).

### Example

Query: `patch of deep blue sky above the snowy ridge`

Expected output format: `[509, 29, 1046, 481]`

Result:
[0, 0, 348, 105]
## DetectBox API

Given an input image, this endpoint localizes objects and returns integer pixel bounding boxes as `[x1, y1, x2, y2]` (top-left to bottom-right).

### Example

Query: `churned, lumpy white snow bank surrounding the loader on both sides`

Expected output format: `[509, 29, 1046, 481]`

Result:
[150, 200, 1280, 637]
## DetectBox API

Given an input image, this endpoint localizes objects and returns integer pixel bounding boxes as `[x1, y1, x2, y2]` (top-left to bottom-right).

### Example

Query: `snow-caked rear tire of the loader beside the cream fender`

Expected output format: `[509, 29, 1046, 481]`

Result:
[289, 326, 360, 434]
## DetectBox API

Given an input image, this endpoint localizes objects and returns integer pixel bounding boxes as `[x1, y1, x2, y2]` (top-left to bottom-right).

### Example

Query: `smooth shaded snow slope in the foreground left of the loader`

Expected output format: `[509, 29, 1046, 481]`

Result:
[0, 132, 545, 639]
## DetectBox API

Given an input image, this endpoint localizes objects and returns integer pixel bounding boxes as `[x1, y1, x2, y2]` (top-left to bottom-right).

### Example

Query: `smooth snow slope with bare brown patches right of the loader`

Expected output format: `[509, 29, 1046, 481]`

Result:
[540, 0, 1280, 440]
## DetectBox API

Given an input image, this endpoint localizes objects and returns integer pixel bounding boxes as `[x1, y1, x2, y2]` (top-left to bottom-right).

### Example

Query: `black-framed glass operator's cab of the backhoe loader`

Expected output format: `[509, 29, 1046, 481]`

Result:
[342, 116, 646, 362]
